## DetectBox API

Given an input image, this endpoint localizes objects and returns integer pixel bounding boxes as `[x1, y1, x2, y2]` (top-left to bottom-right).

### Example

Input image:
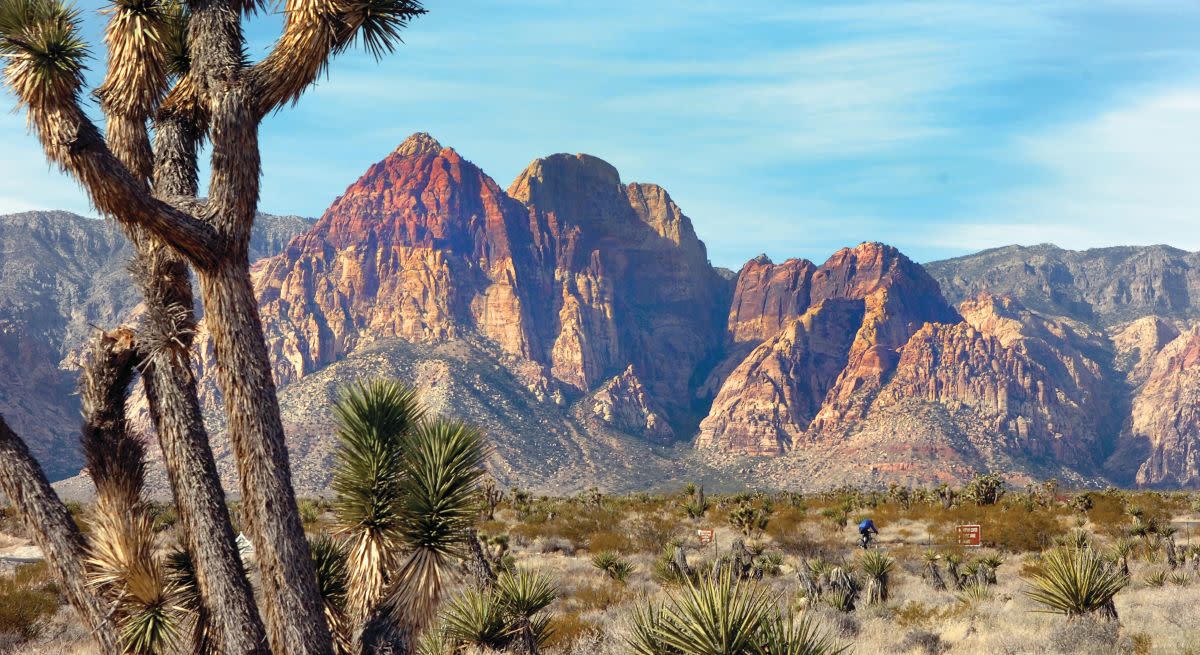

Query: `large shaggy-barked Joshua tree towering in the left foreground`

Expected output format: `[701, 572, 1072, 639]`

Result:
[0, 0, 424, 655]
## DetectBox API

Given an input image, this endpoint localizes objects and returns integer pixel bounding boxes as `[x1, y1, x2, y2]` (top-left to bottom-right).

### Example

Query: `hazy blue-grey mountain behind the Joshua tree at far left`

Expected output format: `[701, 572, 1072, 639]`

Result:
[0, 211, 310, 480]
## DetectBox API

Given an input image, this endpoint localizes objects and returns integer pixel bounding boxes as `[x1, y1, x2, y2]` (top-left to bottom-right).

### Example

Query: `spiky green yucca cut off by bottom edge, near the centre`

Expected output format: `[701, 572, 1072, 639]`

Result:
[659, 571, 774, 655]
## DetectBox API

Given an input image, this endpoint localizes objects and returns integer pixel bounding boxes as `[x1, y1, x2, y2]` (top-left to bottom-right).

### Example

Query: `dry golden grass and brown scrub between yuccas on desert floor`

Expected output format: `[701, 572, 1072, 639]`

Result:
[9, 492, 1200, 655]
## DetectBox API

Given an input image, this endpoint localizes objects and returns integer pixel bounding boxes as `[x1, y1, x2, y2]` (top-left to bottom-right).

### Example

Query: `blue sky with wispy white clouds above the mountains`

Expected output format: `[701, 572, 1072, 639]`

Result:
[0, 0, 1200, 269]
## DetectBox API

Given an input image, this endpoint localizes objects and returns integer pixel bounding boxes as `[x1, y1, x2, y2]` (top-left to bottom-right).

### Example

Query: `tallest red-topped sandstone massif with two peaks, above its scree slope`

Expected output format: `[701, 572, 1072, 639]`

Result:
[232, 134, 727, 438]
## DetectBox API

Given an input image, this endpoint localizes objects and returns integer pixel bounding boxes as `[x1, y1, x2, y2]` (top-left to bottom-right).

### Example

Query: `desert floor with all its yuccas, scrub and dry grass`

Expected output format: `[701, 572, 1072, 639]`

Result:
[0, 470, 1200, 655]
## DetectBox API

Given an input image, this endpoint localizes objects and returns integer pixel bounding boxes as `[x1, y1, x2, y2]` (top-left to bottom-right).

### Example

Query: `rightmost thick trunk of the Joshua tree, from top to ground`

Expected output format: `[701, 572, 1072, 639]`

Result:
[188, 0, 332, 643]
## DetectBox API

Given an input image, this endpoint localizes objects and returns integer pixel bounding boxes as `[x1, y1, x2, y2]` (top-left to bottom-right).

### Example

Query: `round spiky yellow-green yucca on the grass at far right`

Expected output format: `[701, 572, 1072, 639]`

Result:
[1025, 547, 1129, 620]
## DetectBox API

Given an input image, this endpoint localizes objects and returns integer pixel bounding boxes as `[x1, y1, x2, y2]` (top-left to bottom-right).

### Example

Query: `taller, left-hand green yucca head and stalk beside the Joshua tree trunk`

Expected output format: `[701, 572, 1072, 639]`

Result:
[334, 380, 425, 621]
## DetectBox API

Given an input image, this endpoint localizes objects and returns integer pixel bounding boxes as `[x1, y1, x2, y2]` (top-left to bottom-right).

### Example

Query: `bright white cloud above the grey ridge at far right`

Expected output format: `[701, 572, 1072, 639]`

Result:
[942, 83, 1200, 250]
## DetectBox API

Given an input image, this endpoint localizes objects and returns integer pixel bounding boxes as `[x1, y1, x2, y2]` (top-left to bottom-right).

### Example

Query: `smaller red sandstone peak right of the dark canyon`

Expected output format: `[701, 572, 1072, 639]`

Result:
[697, 244, 958, 455]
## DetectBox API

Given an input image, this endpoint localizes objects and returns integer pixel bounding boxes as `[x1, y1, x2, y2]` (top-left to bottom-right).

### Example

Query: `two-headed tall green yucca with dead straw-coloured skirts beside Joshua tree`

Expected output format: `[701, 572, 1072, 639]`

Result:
[334, 380, 487, 639]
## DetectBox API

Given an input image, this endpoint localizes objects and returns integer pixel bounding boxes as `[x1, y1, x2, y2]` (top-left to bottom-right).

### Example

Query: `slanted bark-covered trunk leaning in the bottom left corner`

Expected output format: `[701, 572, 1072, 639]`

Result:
[0, 416, 121, 655]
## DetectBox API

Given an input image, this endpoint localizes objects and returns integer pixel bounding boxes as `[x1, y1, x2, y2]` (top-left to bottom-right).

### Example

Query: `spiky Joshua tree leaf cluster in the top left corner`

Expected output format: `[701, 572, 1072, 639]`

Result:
[0, 0, 89, 109]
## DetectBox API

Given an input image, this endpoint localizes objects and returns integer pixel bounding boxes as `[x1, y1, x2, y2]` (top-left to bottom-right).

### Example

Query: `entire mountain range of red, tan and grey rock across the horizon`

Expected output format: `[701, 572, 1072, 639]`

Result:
[0, 134, 1200, 493]
